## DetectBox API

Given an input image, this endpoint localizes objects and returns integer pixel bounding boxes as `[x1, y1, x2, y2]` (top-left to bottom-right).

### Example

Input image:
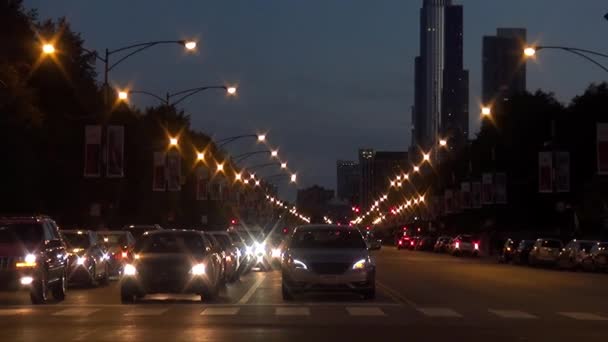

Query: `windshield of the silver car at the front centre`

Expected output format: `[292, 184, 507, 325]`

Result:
[290, 228, 366, 249]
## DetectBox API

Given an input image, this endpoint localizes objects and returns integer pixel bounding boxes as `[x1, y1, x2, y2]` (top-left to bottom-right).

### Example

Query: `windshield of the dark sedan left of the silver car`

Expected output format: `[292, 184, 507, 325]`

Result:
[134, 233, 205, 254]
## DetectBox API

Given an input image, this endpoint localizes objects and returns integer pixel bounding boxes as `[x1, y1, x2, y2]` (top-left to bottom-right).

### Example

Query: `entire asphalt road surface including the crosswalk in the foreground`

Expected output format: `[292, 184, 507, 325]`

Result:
[0, 247, 608, 342]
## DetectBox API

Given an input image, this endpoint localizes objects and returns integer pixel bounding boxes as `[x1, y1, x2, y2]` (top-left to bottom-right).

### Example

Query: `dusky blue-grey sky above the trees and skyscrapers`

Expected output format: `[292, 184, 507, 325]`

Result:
[25, 0, 608, 199]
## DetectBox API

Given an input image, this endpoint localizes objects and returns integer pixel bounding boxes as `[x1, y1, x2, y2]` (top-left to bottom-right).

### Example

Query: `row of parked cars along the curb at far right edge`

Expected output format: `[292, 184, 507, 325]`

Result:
[499, 238, 608, 272]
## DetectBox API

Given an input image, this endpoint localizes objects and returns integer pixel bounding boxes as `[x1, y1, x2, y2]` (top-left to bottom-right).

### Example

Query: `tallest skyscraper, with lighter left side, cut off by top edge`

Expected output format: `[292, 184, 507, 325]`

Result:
[412, 0, 469, 150]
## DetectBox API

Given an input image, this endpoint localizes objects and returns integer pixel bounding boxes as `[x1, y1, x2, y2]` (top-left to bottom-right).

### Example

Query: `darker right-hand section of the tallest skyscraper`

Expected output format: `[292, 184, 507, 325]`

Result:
[439, 5, 469, 147]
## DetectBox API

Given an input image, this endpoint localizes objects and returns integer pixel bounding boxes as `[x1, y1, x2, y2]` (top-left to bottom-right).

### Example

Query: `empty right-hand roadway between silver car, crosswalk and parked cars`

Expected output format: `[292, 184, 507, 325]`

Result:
[376, 248, 608, 312]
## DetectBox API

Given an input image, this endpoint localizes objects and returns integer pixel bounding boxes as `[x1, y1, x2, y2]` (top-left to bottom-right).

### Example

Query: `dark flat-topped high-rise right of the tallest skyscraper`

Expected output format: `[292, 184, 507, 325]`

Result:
[481, 28, 526, 105]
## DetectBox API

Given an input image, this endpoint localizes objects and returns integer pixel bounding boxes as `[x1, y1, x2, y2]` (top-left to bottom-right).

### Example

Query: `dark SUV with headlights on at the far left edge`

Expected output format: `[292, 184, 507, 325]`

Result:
[0, 216, 68, 304]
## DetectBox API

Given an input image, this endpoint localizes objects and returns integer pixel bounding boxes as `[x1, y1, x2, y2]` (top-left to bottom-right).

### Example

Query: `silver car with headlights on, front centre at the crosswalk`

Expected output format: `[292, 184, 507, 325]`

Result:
[281, 225, 376, 300]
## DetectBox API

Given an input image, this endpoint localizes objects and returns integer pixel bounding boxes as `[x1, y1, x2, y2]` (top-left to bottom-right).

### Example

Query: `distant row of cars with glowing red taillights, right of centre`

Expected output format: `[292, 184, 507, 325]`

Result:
[397, 234, 480, 257]
